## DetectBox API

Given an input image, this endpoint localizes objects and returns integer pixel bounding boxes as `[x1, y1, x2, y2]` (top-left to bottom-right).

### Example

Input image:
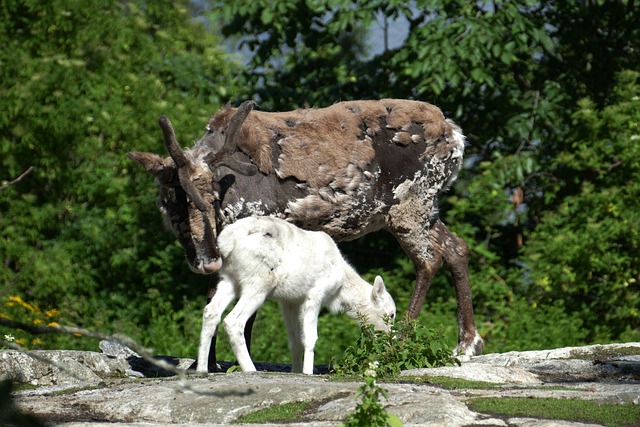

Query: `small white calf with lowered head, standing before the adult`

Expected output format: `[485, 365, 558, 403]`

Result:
[197, 217, 396, 374]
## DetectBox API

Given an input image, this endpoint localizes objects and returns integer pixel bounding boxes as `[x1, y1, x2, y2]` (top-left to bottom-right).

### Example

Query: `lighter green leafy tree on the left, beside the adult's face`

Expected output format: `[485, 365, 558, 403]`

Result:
[0, 0, 236, 351]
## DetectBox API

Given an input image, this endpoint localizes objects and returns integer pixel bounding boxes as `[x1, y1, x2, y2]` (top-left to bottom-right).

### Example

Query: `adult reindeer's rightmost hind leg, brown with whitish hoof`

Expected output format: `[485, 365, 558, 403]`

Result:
[430, 220, 484, 360]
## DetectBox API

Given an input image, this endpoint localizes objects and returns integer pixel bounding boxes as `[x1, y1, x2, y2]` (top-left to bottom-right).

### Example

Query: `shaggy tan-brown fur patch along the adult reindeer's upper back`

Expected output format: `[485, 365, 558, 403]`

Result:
[207, 99, 451, 188]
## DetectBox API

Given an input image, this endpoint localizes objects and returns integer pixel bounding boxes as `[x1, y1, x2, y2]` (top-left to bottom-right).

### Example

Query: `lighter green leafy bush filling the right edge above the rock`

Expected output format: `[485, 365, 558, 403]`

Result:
[522, 72, 640, 341]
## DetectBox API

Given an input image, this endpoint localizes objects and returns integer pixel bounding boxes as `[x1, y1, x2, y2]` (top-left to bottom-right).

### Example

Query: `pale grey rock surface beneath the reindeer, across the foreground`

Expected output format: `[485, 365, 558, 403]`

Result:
[5, 343, 640, 427]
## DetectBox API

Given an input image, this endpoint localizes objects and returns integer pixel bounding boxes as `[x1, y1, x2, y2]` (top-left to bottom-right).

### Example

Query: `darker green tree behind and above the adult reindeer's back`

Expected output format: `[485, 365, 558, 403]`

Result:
[212, 0, 640, 351]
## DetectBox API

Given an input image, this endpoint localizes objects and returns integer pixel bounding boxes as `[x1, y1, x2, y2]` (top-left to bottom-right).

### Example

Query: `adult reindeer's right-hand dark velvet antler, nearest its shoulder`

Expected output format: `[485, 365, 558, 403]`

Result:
[204, 101, 258, 175]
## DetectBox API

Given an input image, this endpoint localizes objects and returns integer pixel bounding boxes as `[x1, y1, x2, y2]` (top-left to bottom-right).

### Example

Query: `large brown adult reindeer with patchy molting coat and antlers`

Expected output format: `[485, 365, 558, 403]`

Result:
[128, 99, 483, 370]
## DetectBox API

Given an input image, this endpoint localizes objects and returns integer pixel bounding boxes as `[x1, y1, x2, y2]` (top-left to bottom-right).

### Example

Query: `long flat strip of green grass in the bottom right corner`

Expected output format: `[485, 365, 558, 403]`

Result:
[467, 397, 640, 427]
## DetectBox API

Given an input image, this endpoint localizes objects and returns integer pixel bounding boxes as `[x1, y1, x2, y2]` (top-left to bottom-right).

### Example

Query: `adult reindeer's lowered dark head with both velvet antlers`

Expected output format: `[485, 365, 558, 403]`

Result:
[127, 101, 257, 274]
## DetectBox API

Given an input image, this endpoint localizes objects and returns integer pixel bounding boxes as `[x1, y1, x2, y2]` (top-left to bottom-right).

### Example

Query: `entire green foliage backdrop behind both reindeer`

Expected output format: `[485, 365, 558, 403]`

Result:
[0, 0, 640, 363]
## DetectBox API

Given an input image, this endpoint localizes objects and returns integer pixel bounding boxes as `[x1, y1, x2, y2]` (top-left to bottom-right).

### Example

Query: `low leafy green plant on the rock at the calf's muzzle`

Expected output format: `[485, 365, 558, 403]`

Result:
[333, 321, 455, 378]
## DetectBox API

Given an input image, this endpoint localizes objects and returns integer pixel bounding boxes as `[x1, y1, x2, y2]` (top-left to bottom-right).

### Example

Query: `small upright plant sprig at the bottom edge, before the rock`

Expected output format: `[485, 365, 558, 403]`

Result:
[343, 362, 402, 427]
